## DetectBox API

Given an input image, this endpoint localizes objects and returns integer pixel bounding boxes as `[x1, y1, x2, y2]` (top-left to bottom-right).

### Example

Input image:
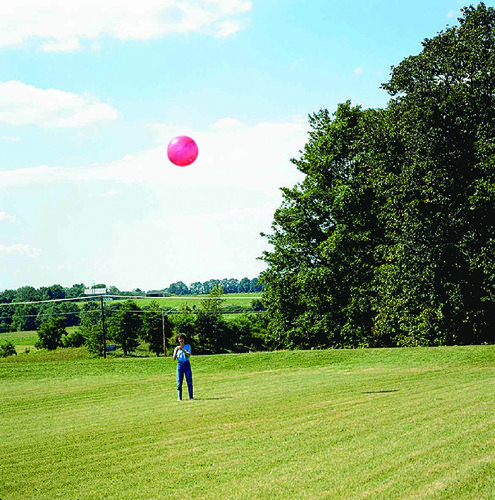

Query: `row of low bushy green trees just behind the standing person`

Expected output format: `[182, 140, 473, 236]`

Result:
[76, 294, 267, 356]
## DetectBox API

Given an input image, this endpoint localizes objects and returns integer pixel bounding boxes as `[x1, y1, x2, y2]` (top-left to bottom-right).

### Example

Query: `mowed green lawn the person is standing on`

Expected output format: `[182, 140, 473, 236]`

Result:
[0, 346, 495, 500]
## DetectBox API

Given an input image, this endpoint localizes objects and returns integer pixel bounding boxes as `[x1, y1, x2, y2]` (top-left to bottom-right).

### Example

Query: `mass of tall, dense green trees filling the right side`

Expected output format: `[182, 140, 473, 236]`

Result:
[260, 3, 495, 348]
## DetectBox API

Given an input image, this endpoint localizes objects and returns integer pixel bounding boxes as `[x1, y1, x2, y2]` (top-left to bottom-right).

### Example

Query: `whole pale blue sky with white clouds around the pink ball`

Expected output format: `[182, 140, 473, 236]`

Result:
[0, 0, 482, 290]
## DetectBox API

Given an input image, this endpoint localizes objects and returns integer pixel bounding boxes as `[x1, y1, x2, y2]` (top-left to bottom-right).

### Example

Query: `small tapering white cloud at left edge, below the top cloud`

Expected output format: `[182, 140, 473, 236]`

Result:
[0, 80, 119, 128]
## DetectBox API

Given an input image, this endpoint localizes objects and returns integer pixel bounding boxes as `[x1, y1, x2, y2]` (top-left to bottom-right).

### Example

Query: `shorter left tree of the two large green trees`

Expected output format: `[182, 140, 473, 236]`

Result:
[260, 102, 381, 347]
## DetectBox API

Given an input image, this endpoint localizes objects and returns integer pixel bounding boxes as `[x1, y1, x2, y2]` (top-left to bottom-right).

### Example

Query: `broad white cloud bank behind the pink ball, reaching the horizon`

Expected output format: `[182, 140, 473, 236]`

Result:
[0, 117, 308, 290]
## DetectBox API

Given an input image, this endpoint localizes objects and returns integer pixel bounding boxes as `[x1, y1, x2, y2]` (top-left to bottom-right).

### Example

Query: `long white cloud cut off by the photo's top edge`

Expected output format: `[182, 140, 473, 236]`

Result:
[0, 0, 252, 52]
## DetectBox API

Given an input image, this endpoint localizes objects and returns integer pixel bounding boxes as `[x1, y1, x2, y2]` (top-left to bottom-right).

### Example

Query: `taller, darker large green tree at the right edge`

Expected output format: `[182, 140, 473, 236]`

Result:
[374, 3, 495, 345]
